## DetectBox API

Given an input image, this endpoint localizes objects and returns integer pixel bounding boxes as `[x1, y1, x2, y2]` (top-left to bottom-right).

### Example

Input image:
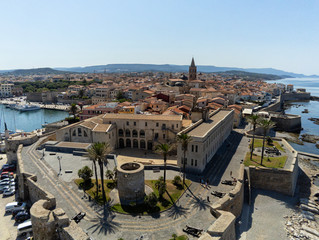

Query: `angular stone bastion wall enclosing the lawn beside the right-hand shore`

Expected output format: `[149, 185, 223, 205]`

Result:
[249, 139, 299, 196]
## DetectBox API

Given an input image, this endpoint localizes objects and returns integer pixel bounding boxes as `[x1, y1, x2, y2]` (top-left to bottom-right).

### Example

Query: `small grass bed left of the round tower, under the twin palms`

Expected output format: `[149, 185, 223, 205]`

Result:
[74, 179, 113, 204]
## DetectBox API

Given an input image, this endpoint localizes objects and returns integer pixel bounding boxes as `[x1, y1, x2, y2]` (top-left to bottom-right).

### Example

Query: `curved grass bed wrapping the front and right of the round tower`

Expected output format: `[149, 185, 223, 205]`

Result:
[111, 180, 191, 214]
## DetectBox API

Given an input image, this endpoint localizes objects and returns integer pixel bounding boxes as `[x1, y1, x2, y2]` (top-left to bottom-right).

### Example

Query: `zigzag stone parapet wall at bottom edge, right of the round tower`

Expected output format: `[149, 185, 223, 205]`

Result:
[199, 164, 245, 240]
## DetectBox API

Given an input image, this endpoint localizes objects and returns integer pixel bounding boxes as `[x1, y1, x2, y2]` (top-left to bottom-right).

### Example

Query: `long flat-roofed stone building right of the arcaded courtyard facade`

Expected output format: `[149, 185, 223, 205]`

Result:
[177, 109, 234, 173]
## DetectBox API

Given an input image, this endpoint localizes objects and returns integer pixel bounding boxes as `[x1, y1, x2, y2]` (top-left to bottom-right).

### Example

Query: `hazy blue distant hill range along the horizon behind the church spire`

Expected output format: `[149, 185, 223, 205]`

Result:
[55, 64, 319, 77]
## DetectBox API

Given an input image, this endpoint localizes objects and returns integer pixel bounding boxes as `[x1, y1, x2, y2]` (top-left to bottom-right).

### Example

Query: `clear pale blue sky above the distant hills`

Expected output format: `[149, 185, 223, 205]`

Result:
[0, 0, 319, 75]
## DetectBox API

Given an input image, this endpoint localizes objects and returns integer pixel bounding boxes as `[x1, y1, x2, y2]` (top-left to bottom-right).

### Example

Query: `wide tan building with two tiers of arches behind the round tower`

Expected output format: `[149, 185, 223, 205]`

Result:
[56, 113, 182, 150]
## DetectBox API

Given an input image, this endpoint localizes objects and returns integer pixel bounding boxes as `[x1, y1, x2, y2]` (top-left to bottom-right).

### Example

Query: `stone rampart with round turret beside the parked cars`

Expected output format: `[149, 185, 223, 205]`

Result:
[16, 144, 89, 240]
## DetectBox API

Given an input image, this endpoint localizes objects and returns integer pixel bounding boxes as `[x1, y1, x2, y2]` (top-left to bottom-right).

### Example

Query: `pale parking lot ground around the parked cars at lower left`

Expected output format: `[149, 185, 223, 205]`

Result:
[0, 154, 28, 240]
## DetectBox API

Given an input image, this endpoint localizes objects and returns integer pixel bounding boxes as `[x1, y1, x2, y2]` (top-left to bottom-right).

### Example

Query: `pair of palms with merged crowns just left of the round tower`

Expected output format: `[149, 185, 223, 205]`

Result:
[88, 142, 112, 203]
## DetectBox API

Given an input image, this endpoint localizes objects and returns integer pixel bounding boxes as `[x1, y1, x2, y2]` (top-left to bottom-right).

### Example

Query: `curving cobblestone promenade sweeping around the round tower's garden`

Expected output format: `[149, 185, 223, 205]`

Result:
[22, 131, 248, 240]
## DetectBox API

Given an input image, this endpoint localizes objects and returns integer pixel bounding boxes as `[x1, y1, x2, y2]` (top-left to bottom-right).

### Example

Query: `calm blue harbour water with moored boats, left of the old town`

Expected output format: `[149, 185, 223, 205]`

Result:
[0, 104, 69, 133]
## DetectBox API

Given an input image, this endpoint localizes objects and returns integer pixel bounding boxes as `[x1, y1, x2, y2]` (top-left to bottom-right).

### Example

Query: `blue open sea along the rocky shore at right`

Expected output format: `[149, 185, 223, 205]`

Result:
[267, 78, 319, 154]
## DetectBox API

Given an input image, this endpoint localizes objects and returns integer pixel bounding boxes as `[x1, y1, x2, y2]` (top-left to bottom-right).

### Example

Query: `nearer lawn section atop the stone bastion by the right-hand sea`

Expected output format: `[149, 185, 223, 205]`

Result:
[244, 152, 287, 168]
